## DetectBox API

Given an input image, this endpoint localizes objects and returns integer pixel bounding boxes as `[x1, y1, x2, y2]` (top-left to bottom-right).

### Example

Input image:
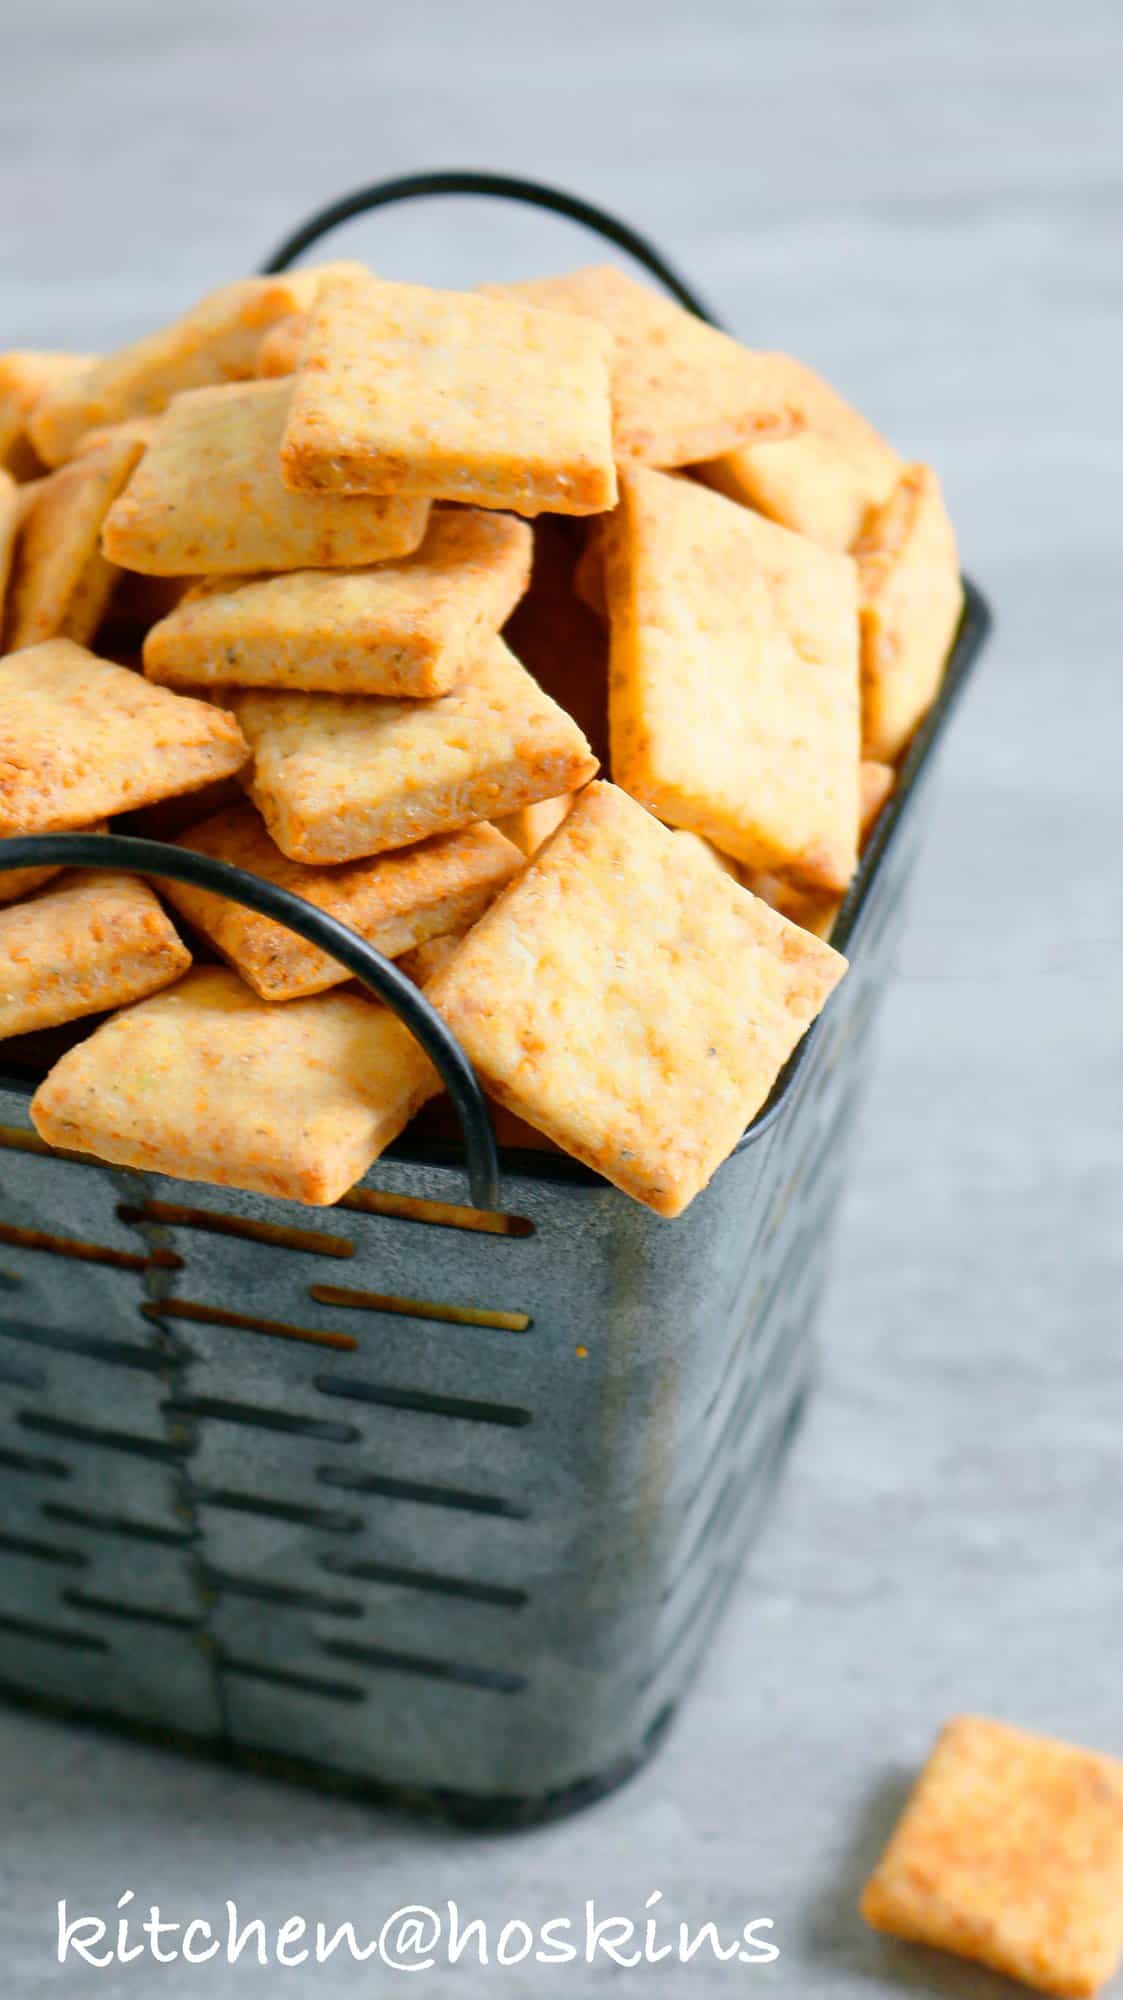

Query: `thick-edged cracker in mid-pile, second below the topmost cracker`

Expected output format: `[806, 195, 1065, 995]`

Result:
[144, 508, 532, 696]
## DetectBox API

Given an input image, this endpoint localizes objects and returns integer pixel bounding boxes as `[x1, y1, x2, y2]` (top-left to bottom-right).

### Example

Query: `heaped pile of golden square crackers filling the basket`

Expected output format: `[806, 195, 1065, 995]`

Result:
[0, 264, 961, 1216]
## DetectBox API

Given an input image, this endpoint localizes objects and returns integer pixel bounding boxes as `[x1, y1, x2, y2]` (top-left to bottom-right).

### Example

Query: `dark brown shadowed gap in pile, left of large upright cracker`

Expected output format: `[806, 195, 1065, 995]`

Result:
[504, 516, 607, 764]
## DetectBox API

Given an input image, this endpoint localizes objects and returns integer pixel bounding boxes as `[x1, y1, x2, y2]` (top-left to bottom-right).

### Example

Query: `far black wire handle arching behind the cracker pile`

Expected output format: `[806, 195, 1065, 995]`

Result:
[262, 168, 717, 326]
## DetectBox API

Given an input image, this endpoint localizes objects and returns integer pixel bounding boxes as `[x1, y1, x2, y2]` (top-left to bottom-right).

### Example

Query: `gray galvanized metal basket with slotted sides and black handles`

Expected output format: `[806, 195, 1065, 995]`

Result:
[0, 174, 989, 1822]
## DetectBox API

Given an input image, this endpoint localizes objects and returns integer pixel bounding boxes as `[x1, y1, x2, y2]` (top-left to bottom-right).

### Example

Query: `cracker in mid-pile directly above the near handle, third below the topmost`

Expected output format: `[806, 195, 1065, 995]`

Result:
[232, 638, 595, 862]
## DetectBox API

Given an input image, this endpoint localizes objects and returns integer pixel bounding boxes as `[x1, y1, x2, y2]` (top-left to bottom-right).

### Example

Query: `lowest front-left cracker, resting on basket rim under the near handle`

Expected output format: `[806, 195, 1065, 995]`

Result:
[32, 966, 440, 1206]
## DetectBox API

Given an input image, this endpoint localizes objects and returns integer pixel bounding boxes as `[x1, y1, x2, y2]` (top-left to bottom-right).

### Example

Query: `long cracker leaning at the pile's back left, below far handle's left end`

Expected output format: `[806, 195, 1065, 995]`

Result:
[28, 272, 316, 466]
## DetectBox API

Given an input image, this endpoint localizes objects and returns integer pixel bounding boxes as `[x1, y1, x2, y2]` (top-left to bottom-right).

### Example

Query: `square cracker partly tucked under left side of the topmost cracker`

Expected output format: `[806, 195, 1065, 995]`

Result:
[102, 382, 430, 576]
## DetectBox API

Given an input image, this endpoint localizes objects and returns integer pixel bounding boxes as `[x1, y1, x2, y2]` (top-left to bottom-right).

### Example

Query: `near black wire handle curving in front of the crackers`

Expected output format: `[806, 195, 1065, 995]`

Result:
[0, 834, 500, 1208]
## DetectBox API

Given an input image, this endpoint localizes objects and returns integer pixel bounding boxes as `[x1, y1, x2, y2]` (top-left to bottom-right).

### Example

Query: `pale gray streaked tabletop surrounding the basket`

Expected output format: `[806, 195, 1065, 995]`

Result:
[0, 0, 1123, 2000]
